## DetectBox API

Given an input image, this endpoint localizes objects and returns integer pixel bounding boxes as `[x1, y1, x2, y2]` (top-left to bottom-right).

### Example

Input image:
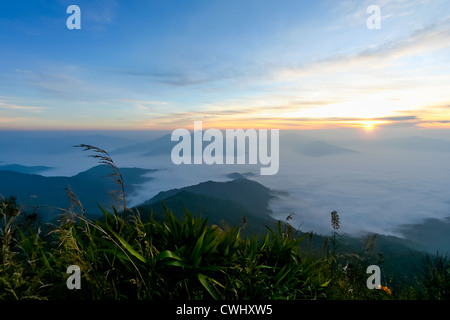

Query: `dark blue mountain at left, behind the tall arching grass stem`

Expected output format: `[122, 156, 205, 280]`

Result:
[0, 165, 154, 219]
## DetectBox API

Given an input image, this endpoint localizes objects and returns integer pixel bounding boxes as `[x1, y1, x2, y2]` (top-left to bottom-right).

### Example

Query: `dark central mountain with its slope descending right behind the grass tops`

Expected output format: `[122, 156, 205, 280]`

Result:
[137, 176, 425, 280]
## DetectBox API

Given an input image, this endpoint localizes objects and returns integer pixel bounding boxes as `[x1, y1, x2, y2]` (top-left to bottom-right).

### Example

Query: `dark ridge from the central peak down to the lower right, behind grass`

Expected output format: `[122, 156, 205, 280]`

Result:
[136, 177, 426, 279]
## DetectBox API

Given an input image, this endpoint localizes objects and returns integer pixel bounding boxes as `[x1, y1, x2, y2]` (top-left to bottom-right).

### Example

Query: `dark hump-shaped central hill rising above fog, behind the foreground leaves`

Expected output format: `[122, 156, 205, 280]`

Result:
[137, 176, 276, 233]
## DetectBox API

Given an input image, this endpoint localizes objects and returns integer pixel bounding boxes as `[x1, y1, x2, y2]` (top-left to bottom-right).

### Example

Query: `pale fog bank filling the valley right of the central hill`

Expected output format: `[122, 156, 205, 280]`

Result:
[251, 132, 450, 236]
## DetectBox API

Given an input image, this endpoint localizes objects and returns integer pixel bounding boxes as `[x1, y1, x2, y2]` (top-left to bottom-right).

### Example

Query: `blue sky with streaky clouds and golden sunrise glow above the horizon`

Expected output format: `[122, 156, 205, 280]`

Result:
[0, 0, 450, 131]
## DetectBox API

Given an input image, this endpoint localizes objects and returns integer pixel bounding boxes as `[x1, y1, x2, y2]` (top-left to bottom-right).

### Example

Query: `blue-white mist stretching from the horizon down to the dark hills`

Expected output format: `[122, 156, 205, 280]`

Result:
[0, 130, 450, 252]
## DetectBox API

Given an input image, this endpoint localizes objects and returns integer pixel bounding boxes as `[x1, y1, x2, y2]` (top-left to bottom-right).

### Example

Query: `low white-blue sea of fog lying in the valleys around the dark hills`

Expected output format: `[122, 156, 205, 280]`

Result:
[0, 129, 450, 249]
